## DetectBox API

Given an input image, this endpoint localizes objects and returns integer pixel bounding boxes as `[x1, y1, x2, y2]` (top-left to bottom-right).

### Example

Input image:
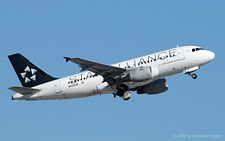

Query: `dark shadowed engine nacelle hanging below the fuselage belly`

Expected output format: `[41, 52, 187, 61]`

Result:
[137, 78, 168, 94]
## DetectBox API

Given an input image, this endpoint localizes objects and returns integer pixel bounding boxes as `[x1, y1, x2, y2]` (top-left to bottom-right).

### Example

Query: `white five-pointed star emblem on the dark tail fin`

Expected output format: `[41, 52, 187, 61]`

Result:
[20, 66, 37, 83]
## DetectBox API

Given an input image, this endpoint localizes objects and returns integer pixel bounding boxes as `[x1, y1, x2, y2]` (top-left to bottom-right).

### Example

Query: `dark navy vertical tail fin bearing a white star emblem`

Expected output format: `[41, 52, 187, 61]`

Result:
[8, 53, 56, 87]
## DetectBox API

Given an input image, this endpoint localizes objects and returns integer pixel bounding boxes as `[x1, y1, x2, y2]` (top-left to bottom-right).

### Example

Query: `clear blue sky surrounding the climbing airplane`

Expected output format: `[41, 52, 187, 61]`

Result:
[0, 0, 225, 141]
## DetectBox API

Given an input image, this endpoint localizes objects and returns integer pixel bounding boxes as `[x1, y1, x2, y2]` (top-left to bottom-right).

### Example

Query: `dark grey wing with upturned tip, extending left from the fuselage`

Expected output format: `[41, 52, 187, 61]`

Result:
[64, 57, 126, 82]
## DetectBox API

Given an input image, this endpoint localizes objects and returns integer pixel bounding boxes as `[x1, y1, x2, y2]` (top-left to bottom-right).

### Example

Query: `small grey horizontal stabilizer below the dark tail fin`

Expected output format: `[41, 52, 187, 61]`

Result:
[9, 86, 41, 95]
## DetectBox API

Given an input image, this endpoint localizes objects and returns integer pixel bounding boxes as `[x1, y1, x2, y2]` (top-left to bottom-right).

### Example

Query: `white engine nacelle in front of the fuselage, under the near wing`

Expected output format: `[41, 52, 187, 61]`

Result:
[122, 67, 159, 82]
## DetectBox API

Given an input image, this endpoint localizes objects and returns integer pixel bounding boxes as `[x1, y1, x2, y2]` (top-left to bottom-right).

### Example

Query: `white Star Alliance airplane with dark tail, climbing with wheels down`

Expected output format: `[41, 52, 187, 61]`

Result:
[8, 46, 215, 101]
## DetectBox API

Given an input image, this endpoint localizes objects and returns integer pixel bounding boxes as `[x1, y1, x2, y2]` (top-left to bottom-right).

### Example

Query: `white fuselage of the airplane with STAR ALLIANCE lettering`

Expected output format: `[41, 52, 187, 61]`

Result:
[13, 46, 215, 100]
